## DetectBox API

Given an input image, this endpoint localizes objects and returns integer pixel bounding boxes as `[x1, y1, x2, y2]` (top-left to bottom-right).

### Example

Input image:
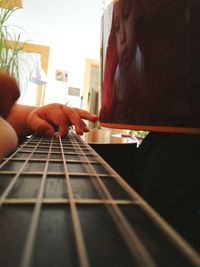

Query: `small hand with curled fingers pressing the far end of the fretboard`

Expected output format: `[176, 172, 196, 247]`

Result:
[27, 103, 98, 136]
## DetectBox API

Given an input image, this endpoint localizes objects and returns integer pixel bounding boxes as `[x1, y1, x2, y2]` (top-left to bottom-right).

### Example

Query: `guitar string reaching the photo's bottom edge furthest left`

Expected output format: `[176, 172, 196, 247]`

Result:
[20, 137, 54, 267]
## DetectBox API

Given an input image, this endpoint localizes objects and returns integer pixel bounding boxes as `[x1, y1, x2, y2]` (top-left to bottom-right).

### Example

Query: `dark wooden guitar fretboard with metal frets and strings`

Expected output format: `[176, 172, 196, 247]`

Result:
[0, 133, 200, 267]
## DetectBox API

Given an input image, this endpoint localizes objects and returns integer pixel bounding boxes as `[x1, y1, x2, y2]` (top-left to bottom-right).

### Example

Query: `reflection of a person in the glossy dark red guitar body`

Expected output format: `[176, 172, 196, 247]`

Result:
[100, 0, 145, 124]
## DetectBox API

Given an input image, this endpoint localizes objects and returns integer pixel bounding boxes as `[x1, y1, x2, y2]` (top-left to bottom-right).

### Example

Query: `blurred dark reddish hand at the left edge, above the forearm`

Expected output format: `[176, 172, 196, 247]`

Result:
[0, 72, 20, 118]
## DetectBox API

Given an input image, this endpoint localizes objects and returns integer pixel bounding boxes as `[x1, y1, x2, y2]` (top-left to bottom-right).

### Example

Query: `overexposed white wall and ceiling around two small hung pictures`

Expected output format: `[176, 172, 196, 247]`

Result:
[7, 0, 102, 106]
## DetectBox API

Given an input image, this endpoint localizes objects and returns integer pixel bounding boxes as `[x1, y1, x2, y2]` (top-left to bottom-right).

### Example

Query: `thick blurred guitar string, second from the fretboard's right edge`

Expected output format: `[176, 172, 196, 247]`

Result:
[72, 135, 156, 267]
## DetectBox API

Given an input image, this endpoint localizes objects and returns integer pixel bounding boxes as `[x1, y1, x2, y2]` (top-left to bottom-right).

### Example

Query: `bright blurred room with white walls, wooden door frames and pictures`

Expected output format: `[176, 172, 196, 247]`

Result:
[1, 0, 111, 112]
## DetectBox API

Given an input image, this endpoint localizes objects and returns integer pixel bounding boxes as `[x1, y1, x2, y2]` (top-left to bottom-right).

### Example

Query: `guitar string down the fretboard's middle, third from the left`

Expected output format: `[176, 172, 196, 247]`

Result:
[59, 136, 90, 267]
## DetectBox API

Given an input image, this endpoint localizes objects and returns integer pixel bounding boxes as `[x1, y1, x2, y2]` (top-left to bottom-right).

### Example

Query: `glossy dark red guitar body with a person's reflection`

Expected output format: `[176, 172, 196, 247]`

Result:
[100, 0, 200, 127]
